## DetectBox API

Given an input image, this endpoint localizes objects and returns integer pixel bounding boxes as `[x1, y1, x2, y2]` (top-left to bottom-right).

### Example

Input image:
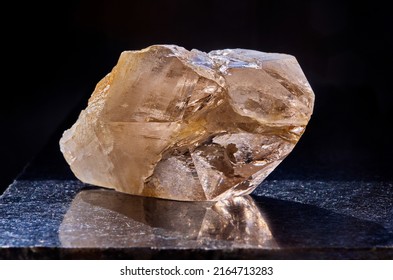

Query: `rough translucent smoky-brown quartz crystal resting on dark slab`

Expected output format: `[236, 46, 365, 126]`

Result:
[60, 45, 314, 201]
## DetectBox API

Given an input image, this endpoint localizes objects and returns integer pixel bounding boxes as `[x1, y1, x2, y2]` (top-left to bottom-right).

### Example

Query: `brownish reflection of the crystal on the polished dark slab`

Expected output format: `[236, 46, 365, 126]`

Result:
[59, 189, 278, 249]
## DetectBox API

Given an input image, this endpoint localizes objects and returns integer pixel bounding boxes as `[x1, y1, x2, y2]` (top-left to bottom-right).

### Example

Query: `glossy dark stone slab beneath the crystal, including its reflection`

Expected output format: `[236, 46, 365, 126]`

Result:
[0, 132, 393, 259]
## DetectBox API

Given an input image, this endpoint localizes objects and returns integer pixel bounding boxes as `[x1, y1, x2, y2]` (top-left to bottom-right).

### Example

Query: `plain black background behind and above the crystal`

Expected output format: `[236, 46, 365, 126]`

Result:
[0, 0, 393, 193]
